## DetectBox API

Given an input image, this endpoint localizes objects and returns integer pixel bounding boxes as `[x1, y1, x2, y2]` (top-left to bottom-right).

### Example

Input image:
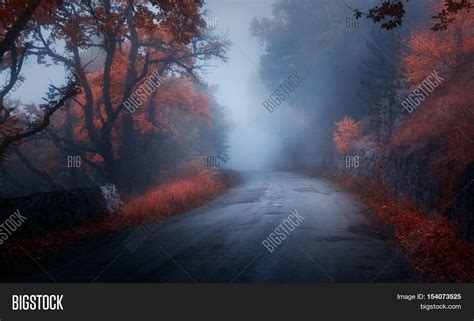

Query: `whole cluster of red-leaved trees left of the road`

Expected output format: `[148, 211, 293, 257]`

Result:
[0, 0, 229, 195]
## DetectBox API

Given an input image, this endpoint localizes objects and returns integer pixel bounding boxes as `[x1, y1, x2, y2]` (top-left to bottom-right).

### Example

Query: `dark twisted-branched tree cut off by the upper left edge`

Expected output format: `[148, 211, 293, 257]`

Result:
[0, 0, 78, 162]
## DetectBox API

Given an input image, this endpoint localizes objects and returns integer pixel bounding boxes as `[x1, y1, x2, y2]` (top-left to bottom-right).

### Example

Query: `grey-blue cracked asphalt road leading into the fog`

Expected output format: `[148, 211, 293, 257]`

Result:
[4, 172, 418, 283]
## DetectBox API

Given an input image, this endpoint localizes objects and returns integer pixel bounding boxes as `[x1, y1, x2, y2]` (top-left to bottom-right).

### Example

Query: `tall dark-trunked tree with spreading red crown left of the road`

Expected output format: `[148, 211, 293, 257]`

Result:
[28, 0, 230, 183]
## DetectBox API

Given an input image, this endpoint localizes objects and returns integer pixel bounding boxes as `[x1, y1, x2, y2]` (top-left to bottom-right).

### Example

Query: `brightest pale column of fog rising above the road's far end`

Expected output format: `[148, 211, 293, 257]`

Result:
[205, 0, 280, 169]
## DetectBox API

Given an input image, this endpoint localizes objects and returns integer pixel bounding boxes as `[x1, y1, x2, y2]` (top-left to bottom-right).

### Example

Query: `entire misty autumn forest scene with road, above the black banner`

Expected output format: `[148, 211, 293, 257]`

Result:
[0, 0, 474, 283]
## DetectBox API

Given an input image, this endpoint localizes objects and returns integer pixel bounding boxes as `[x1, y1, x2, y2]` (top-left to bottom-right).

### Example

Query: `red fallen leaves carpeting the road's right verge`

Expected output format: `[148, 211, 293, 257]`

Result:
[331, 171, 474, 282]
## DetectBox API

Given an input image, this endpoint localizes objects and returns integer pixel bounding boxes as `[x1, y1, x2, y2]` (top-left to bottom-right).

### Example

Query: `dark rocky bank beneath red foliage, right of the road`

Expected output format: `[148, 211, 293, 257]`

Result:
[335, 137, 474, 242]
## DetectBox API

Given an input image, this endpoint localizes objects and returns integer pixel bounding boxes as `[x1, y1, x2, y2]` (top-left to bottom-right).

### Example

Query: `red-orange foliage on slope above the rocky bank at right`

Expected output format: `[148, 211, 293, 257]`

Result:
[392, 30, 474, 207]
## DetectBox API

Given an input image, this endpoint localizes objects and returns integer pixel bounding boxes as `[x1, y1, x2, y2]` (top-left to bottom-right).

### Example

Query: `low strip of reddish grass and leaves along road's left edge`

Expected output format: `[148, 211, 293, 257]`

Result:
[0, 169, 237, 273]
